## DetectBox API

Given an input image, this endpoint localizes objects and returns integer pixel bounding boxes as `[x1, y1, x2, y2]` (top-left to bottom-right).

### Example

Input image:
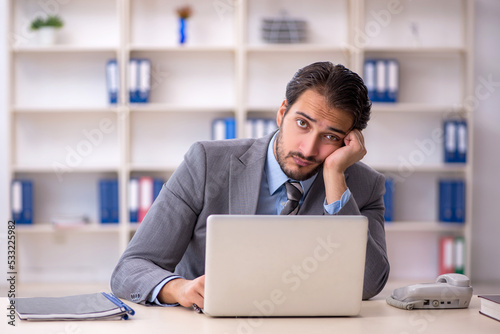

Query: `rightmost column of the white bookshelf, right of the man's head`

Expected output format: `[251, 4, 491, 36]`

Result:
[354, 0, 474, 279]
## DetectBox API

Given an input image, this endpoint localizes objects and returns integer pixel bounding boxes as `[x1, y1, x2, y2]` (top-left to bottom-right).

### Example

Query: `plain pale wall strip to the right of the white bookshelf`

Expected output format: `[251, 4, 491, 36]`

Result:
[471, 0, 500, 283]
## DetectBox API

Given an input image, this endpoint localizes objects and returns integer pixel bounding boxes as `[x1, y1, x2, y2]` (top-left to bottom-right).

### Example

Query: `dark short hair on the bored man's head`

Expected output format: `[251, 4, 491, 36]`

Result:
[285, 62, 372, 130]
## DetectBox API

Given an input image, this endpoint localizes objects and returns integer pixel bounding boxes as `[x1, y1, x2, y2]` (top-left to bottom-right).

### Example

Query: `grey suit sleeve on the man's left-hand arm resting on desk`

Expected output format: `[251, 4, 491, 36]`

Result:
[111, 144, 206, 304]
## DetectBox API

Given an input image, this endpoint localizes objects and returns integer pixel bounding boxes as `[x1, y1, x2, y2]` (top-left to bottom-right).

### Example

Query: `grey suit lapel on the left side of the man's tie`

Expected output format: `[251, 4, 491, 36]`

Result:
[229, 134, 273, 215]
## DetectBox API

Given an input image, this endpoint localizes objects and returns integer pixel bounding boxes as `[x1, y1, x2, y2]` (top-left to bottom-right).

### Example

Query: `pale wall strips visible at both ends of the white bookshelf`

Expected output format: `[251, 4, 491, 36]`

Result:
[0, 0, 500, 285]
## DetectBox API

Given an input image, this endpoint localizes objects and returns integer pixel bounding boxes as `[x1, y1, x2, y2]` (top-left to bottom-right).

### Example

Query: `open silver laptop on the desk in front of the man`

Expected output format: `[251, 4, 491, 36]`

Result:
[204, 215, 368, 317]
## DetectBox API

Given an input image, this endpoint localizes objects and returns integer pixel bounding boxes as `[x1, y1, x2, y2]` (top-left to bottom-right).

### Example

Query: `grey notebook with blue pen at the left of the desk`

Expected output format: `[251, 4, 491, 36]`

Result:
[15, 292, 135, 321]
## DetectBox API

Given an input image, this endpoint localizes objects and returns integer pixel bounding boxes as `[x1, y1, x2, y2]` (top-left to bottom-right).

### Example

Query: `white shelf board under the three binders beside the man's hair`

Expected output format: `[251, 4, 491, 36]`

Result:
[372, 102, 466, 114]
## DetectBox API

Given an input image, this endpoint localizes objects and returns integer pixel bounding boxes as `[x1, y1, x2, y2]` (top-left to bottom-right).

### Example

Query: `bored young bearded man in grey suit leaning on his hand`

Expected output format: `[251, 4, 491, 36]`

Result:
[111, 62, 389, 307]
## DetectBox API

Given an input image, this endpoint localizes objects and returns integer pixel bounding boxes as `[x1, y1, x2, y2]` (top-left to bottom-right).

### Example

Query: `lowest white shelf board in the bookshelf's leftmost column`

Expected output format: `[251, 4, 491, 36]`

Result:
[16, 223, 120, 234]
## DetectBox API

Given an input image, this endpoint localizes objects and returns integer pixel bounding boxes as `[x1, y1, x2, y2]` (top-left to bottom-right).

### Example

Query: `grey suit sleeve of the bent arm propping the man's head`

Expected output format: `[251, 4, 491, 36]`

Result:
[338, 173, 389, 299]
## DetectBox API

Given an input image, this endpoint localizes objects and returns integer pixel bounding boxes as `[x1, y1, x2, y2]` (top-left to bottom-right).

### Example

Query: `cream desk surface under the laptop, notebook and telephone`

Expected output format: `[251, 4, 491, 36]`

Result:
[0, 296, 500, 334]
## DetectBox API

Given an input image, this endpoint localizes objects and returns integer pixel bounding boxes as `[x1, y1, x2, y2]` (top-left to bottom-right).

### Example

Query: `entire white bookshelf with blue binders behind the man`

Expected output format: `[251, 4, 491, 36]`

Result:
[8, 0, 473, 281]
